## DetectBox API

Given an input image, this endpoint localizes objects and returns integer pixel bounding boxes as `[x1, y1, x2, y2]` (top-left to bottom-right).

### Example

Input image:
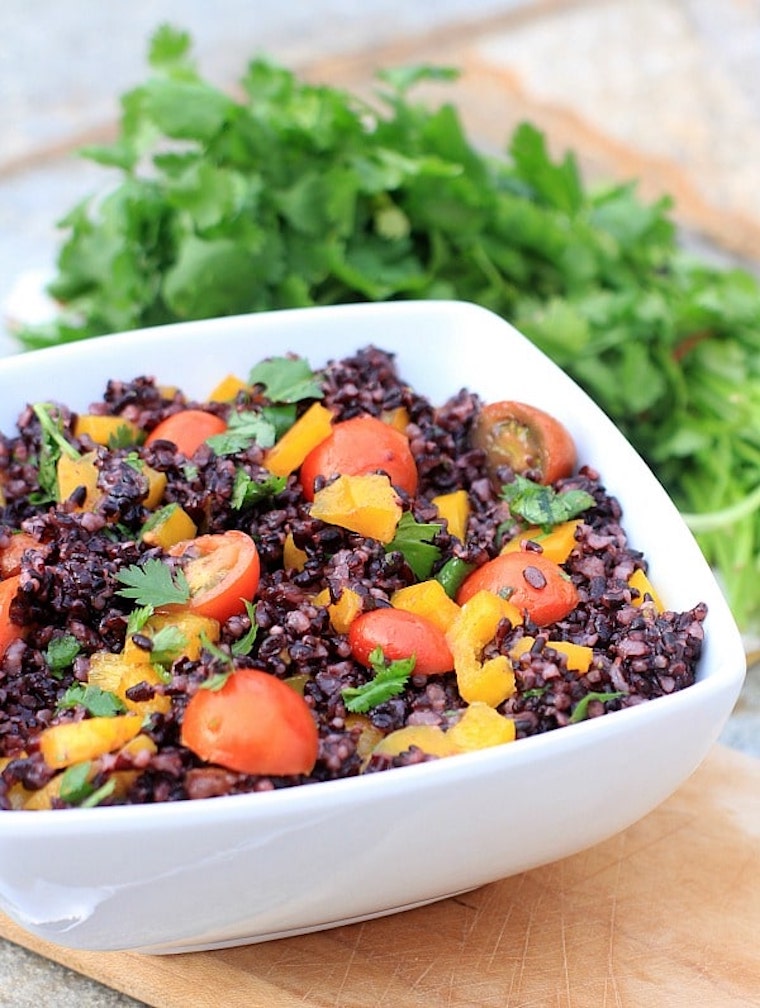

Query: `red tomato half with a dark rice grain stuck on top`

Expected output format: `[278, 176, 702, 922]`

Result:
[457, 549, 580, 626]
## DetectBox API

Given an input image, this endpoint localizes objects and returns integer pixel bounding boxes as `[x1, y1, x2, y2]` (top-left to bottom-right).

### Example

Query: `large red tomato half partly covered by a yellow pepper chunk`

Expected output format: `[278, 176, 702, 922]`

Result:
[300, 414, 417, 500]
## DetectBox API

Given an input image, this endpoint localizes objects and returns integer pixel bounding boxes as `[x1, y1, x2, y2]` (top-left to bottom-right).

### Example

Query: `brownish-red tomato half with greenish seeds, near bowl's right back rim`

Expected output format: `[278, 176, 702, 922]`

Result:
[473, 399, 577, 484]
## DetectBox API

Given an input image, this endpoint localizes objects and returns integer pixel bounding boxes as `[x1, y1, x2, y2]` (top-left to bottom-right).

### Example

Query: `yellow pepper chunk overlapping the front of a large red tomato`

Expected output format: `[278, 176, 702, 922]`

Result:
[311, 473, 402, 542]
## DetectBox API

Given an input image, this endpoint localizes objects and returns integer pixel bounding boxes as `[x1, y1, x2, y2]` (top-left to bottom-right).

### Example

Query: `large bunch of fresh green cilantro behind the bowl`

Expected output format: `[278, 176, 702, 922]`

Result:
[20, 26, 760, 627]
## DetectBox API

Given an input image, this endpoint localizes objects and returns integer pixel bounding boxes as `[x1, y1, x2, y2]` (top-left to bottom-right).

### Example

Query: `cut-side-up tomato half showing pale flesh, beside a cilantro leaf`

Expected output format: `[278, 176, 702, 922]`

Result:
[166, 529, 261, 623]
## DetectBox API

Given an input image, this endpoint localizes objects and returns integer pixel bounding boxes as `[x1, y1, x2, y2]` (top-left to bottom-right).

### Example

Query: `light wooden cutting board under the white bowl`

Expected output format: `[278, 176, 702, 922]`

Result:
[0, 746, 760, 1008]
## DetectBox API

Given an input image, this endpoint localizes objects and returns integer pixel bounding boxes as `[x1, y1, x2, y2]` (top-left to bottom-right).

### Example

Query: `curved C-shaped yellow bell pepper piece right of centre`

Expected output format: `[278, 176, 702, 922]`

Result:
[447, 591, 522, 707]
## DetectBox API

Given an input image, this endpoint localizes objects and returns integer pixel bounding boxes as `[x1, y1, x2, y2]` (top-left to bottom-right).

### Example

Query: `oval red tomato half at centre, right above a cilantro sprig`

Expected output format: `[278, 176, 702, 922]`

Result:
[349, 609, 454, 675]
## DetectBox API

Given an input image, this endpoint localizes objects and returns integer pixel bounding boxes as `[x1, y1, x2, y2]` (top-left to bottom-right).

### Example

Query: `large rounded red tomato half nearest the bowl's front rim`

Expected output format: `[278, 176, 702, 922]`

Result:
[181, 668, 320, 776]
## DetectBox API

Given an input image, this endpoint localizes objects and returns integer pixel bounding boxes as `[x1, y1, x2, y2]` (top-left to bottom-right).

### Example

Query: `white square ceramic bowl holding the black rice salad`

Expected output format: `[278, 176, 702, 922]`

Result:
[0, 301, 745, 953]
